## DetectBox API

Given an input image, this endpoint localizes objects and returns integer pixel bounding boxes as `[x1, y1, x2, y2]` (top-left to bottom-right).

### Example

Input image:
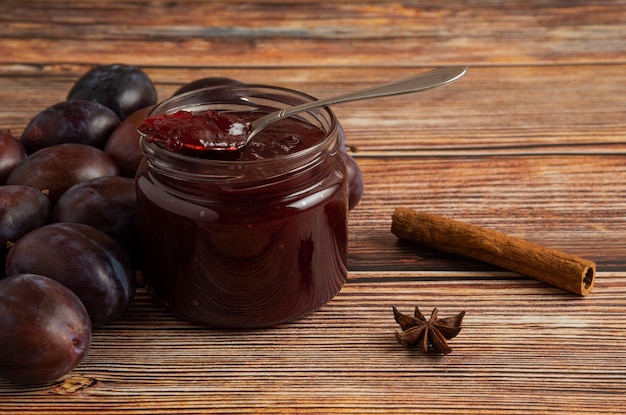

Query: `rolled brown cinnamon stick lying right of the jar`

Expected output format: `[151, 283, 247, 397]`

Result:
[391, 208, 596, 296]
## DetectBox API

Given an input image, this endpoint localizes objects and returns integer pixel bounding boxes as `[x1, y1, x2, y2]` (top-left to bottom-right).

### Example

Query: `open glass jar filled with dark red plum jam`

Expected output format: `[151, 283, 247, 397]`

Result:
[136, 85, 348, 328]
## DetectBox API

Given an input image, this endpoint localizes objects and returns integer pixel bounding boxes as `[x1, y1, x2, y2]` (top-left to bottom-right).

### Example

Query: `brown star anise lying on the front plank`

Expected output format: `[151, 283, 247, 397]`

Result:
[393, 306, 465, 354]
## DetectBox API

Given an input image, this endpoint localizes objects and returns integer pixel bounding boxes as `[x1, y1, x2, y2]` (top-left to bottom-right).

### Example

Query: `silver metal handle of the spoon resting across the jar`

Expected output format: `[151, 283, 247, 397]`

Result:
[240, 66, 467, 147]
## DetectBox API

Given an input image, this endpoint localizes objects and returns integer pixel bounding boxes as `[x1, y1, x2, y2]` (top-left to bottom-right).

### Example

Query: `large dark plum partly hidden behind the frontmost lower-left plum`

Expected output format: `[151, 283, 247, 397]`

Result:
[6, 223, 135, 327]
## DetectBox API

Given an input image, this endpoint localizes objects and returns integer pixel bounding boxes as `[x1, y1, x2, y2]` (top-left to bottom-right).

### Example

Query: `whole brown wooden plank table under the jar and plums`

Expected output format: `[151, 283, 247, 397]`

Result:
[0, 0, 626, 415]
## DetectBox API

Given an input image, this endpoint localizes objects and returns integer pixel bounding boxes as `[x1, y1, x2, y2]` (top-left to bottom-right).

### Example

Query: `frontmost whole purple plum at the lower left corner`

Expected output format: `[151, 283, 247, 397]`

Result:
[0, 274, 91, 385]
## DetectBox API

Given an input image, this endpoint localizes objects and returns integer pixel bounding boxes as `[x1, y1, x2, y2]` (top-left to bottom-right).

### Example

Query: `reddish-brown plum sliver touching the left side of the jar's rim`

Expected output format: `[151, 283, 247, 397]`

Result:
[104, 106, 154, 178]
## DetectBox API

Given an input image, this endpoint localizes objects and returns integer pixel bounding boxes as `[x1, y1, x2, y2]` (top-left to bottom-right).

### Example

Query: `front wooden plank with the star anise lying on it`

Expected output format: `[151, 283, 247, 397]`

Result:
[0, 273, 626, 415]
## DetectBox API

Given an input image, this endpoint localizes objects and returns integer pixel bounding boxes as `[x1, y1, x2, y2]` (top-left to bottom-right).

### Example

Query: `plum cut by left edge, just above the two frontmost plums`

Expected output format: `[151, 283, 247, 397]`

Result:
[0, 185, 51, 278]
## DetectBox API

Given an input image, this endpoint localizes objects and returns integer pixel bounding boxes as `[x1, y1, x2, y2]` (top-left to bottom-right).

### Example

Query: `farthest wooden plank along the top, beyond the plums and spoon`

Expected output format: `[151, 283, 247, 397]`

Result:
[0, 0, 626, 67]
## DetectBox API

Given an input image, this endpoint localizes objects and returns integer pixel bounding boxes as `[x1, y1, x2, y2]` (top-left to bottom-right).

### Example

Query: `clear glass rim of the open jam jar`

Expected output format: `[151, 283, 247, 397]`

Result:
[139, 84, 339, 166]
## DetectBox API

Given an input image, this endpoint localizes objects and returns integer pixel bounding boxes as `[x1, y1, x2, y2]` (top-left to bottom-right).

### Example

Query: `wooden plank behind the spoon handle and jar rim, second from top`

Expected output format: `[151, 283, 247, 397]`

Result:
[0, 65, 626, 156]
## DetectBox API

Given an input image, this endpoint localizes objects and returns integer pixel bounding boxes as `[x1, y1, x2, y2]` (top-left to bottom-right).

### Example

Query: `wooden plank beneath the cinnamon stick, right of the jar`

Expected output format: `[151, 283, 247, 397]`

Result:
[350, 155, 626, 271]
